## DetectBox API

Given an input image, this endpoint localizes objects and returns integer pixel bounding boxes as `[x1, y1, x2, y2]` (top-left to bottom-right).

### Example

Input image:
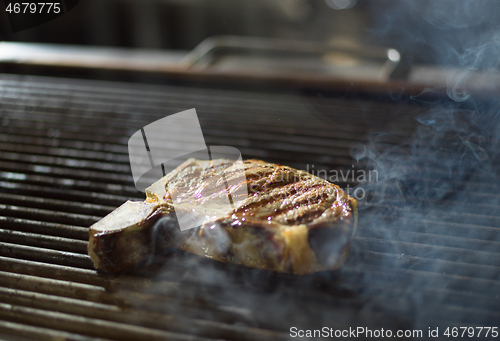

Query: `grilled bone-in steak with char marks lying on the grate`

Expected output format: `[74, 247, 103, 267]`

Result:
[89, 159, 357, 274]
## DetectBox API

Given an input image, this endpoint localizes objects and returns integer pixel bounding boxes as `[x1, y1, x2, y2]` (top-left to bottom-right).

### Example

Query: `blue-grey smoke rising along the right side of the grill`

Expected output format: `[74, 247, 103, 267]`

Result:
[351, 1, 500, 329]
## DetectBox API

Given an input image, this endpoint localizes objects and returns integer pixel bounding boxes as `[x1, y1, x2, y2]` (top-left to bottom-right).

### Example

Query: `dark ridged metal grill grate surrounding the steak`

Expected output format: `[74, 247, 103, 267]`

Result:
[0, 75, 500, 340]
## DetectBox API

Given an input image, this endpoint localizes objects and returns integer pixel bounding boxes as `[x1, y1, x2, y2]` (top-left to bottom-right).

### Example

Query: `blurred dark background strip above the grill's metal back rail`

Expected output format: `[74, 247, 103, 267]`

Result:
[0, 0, 500, 64]
